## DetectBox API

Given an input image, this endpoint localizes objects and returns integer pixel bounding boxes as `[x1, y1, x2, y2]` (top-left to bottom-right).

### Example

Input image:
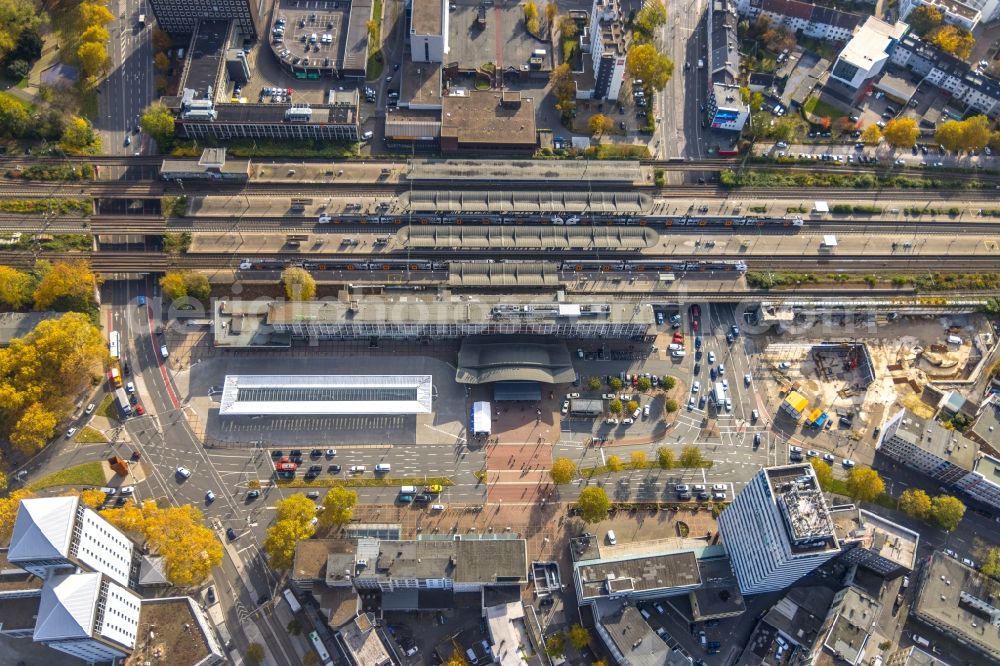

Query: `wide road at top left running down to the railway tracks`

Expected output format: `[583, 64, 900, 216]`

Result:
[95, 0, 155, 155]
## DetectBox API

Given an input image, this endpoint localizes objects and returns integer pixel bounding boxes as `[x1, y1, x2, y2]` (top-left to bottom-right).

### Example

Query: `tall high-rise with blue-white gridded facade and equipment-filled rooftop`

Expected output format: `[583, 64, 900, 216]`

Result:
[719, 464, 841, 595]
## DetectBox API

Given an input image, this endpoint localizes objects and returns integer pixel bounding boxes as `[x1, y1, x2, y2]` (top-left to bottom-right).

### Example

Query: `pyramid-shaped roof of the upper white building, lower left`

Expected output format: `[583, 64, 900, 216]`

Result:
[7, 497, 79, 562]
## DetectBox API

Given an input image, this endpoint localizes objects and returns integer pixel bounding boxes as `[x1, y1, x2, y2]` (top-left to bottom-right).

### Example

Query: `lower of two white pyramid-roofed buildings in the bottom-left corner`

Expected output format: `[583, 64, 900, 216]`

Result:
[33, 572, 142, 663]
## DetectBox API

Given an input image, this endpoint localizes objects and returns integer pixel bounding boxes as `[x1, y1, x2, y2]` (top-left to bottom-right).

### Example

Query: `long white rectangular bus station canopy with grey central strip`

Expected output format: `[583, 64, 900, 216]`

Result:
[219, 375, 433, 416]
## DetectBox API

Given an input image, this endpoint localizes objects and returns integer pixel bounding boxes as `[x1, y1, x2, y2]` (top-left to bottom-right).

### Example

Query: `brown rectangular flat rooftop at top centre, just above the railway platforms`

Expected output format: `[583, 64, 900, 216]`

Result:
[441, 90, 538, 149]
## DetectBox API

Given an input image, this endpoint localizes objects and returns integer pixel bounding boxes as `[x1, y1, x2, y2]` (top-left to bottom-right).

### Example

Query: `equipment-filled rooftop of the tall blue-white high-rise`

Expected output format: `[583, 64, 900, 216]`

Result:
[765, 464, 839, 554]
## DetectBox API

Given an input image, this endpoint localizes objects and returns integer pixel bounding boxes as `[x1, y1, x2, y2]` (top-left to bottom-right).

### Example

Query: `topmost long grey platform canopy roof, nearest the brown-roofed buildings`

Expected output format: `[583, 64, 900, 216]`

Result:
[406, 159, 642, 185]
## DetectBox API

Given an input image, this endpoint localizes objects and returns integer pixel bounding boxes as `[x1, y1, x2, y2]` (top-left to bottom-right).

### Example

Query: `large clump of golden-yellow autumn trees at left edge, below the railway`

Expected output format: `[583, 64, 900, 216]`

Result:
[0, 312, 108, 455]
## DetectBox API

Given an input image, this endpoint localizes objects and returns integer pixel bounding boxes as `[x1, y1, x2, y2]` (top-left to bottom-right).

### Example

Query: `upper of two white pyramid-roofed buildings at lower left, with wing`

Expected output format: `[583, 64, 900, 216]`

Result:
[7, 497, 134, 587]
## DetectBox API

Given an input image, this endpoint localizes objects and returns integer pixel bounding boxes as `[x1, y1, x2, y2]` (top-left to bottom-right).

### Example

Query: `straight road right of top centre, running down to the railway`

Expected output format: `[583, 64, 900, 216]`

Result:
[656, 0, 707, 160]
